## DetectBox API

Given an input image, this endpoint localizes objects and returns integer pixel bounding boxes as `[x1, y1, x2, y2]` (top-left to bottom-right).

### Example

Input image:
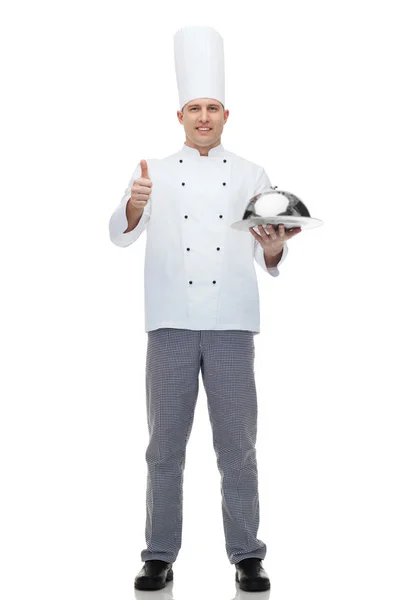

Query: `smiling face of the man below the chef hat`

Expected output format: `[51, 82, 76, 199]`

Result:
[177, 98, 229, 146]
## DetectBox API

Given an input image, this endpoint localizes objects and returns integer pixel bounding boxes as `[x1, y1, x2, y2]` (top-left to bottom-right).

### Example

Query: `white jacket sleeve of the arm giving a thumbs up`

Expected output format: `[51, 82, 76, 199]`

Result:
[109, 163, 151, 248]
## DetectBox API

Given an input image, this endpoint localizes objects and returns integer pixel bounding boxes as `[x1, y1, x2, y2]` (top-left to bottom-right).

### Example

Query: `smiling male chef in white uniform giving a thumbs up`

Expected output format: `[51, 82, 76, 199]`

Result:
[109, 26, 300, 591]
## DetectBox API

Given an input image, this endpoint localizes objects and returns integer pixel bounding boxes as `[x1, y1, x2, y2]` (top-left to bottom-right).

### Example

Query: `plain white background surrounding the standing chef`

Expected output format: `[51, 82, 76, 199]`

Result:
[0, 0, 408, 600]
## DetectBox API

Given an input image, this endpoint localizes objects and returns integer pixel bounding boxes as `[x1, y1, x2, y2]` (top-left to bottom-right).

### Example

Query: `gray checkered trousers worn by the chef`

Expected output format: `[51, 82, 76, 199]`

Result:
[141, 327, 266, 564]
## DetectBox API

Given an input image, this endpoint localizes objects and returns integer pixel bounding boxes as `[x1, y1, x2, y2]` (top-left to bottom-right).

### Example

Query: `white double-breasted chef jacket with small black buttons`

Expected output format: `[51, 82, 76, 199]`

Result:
[109, 144, 288, 335]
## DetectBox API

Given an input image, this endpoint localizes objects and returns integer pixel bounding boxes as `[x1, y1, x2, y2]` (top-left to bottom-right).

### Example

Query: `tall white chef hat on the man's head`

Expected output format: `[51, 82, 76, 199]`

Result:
[174, 25, 225, 110]
